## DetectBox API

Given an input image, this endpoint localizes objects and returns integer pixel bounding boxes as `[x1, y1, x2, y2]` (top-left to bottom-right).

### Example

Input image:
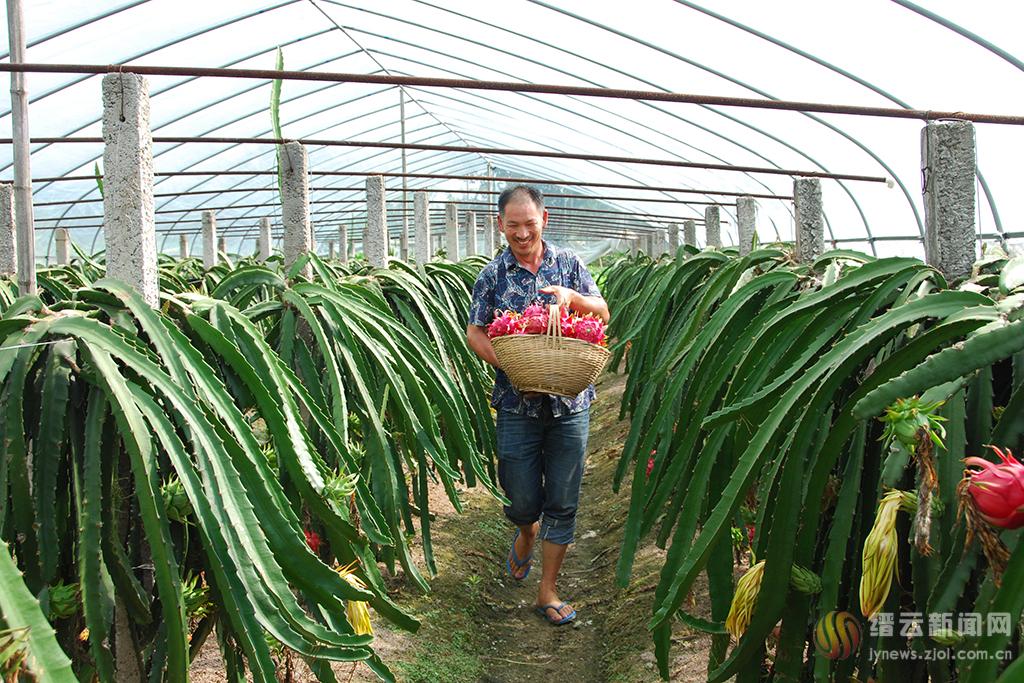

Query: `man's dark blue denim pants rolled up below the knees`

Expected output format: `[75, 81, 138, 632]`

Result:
[498, 405, 590, 545]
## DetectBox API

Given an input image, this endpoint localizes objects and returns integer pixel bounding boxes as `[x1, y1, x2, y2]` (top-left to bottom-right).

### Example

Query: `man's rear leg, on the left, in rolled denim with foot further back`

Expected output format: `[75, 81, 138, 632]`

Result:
[497, 411, 544, 579]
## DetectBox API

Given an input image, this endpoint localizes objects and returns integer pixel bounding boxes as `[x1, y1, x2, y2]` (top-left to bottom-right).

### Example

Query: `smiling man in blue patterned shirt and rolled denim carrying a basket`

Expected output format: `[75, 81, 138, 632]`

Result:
[466, 185, 608, 625]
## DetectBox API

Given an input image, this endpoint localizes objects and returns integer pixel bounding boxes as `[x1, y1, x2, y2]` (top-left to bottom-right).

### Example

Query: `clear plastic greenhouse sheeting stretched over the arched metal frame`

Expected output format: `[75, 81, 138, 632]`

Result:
[0, 0, 1024, 260]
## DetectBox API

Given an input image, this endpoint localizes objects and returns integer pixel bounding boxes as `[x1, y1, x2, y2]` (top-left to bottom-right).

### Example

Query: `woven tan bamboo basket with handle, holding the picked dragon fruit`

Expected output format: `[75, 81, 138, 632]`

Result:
[490, 305, 611, 398]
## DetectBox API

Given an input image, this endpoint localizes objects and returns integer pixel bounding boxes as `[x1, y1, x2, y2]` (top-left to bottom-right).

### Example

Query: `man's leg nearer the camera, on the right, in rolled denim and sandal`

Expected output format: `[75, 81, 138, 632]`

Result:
[537, 411, 590, 618]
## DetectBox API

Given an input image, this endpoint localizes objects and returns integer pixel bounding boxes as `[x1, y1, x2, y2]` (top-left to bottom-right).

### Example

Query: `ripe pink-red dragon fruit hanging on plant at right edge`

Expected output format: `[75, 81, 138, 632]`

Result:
[964, 445, 1024, 529]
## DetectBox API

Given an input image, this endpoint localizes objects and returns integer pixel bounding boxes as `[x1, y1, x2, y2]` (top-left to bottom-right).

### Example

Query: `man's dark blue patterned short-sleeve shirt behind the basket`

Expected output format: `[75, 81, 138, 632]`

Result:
[469, 242, 601, 418]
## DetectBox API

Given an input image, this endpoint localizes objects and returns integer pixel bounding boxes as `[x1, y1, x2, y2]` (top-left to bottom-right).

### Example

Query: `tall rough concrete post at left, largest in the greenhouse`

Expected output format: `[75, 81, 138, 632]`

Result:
[101, 73, 160, 307]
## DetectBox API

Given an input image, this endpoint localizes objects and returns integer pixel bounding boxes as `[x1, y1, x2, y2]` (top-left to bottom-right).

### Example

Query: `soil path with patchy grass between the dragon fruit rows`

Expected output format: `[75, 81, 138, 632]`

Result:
[191, 375, 711, 683]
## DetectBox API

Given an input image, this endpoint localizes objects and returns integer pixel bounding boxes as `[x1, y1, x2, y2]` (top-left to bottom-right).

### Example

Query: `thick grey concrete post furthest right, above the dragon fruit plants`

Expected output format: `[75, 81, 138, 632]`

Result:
[921, 121, 977, 282]
